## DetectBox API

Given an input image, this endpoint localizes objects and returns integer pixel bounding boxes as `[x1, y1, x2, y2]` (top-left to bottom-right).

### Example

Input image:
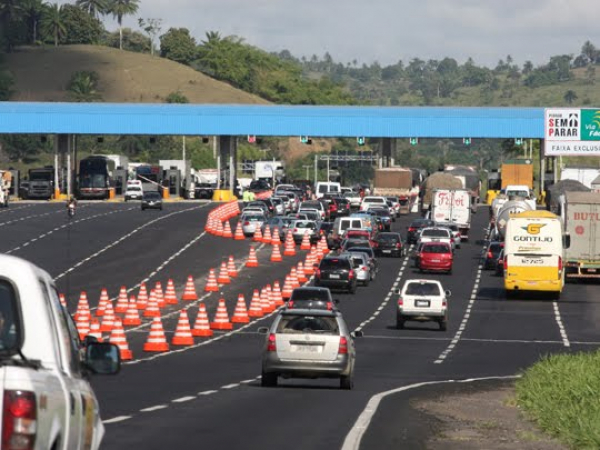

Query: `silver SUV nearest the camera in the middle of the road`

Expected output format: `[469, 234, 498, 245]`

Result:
[258, 309, 356, 389]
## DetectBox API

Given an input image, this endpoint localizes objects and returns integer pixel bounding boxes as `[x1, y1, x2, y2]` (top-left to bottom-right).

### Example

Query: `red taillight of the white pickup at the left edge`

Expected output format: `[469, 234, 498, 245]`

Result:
[2, 390, 37, 450]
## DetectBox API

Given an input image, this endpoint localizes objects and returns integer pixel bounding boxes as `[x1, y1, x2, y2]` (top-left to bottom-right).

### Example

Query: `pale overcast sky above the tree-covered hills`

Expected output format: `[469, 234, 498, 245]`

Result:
[94, 0, 600, 67]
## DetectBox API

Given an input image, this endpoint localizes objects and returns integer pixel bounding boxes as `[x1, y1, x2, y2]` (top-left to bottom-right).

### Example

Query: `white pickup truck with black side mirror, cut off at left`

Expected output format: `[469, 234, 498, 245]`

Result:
[0, 255, 120, 450]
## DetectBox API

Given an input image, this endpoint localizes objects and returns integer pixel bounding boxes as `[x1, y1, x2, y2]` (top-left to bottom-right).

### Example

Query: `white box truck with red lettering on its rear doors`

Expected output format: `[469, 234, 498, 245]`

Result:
[430, 189, 471, 241]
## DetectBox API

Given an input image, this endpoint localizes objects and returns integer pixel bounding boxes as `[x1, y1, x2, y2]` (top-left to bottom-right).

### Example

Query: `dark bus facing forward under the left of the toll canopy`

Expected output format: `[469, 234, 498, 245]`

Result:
[77, 155, 115, 199]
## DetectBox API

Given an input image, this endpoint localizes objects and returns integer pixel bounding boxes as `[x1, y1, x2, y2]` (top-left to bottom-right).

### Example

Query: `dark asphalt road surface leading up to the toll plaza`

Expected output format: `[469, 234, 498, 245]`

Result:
[5, 202, 600, 450]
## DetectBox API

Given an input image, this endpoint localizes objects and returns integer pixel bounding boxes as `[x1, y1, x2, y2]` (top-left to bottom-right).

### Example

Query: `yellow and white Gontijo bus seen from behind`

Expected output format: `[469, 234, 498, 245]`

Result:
[504, 211, 570, 298]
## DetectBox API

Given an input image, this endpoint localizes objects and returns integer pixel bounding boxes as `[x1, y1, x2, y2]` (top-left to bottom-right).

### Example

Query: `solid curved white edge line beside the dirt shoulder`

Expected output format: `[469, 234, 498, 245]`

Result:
[342, 375, 519, 450]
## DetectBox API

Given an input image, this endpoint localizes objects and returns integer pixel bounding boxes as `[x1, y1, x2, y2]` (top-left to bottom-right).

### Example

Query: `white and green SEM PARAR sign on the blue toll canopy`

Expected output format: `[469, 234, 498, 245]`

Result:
[544, 108, 600, 156]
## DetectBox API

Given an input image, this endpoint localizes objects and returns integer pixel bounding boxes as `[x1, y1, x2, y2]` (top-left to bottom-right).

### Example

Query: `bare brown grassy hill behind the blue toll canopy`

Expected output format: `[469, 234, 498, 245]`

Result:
[5, 45, 269, 104]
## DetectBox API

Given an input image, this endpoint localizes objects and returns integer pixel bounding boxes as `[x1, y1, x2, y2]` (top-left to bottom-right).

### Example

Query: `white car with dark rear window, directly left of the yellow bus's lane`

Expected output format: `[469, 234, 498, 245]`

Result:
[396, 279, 452, 331]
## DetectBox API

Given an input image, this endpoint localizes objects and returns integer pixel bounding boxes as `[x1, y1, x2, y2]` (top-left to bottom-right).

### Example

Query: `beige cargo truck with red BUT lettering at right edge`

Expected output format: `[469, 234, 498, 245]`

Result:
[559, 192, 600, 279]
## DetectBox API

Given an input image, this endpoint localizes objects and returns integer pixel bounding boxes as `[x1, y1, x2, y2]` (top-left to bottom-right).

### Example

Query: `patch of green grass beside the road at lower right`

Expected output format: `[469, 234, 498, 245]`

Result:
[516, 352, 600, 449]
